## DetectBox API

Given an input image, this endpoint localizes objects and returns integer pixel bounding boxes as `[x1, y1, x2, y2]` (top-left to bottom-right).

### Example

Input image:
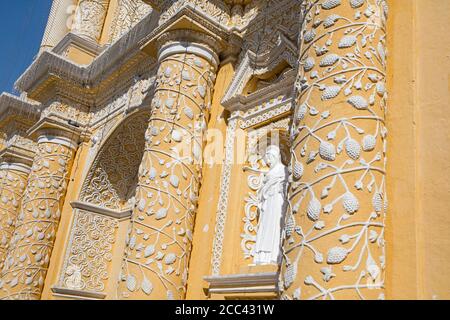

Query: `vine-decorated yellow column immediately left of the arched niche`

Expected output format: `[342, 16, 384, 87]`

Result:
[0, 128, 78, 300]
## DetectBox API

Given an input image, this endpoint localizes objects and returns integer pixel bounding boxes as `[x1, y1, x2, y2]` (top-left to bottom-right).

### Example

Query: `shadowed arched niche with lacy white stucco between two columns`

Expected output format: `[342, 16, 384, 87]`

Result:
[52, 110, 150, 299]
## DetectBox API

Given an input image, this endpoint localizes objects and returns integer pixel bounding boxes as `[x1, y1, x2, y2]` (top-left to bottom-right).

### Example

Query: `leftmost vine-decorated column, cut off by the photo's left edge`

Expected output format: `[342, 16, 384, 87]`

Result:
[0, 162, 30, 270]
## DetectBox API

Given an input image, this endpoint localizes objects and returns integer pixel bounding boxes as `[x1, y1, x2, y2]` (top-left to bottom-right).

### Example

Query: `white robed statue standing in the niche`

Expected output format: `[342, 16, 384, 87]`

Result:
[253, 145, 288, 265]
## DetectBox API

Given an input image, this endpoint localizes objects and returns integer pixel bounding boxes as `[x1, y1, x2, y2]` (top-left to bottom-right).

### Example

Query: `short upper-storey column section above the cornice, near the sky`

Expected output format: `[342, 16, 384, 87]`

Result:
[72, 0, 110, 42]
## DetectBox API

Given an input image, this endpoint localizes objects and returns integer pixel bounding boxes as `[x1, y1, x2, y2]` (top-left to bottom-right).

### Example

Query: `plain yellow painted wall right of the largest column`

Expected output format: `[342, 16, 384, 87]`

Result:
[386, 0, 450, 299]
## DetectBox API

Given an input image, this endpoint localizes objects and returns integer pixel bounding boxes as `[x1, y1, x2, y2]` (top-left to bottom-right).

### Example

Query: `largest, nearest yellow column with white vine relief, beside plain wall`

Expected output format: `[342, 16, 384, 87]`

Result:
[281, 0, 387, 299]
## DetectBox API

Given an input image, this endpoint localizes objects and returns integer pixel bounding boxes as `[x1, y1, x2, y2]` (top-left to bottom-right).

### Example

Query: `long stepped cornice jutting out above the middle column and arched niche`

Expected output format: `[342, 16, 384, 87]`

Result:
[16, 2, 264, 106]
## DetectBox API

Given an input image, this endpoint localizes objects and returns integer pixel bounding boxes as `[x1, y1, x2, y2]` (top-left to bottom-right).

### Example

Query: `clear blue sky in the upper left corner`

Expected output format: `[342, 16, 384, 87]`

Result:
[0, 0, 52, 93]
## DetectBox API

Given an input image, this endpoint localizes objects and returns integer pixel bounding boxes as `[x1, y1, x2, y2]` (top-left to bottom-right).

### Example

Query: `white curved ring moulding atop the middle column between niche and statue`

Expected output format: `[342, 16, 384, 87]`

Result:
[158, 42, 219, 70]
